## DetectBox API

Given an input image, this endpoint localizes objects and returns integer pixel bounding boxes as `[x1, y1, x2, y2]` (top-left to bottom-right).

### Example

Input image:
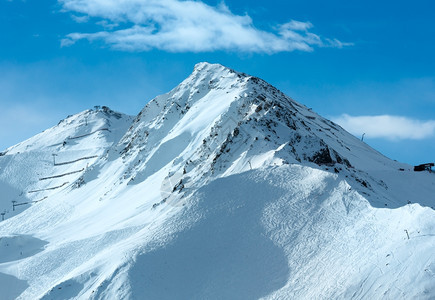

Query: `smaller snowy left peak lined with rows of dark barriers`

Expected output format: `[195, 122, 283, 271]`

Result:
[0, 107, 132, 217]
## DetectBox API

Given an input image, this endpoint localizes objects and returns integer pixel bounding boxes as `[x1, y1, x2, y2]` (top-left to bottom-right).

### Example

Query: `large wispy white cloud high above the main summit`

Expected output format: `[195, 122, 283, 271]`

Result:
[59, 0, 351, 53]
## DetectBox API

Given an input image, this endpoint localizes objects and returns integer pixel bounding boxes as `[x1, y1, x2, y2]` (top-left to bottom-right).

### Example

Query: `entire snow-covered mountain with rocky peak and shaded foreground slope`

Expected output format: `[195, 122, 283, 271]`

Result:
[0, 63, 435, 299]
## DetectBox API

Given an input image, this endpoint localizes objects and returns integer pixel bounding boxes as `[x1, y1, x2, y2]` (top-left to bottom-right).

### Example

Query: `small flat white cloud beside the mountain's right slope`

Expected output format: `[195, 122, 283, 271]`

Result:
[332, 114, 435, 140]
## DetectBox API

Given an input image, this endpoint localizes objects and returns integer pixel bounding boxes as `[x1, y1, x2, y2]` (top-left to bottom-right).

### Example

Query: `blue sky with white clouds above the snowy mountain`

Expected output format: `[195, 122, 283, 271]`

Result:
[0, 0, 435, 164]
